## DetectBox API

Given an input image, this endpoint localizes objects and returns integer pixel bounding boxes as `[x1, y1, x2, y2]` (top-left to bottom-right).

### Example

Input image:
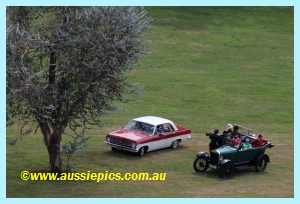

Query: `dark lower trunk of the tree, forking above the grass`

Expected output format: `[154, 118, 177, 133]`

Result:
[40, 123, 62, 173]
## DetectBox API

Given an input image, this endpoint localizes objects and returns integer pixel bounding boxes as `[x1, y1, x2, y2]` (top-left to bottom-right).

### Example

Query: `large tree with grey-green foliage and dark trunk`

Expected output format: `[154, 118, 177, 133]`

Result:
[6, 7, 151, 173]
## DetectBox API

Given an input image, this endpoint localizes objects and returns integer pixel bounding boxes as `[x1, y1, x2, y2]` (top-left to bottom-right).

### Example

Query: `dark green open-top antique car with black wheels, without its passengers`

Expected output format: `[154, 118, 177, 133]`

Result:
[193, 124, 275, 178]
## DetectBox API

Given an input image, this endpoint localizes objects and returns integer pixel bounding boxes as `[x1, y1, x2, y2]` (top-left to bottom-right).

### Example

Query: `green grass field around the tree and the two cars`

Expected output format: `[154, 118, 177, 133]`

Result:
[6, 7, 294, 198]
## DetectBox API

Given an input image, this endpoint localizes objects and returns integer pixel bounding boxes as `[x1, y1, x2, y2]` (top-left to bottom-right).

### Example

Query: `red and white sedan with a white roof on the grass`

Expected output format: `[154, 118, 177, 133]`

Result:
[105, 116, 191, 156]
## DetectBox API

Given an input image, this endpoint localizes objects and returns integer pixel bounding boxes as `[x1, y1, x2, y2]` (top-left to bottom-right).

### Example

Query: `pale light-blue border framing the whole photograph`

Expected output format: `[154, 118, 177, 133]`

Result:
[0, 0, 300, 204]
